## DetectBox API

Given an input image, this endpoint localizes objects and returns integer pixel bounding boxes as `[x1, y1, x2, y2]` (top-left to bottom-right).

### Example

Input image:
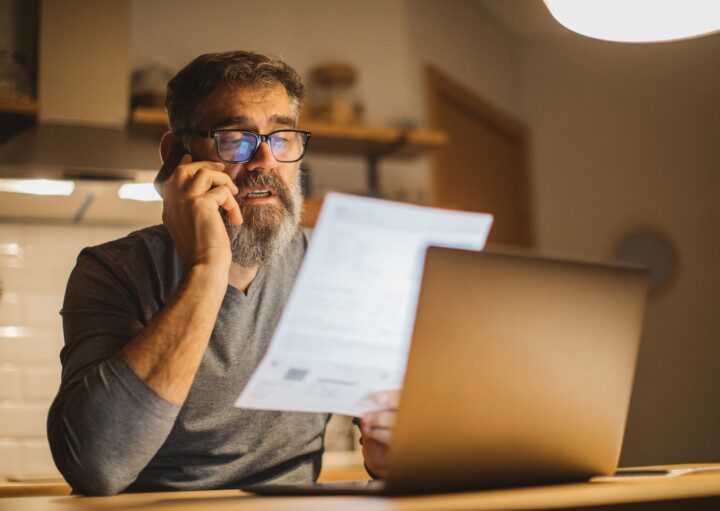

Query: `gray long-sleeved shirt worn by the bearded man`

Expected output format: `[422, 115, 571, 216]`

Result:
[48, 225, 329, 494]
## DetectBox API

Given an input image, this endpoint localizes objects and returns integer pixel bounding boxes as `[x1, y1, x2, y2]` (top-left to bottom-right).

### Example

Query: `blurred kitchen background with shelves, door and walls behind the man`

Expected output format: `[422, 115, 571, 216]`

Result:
[0, 0, 720, 479]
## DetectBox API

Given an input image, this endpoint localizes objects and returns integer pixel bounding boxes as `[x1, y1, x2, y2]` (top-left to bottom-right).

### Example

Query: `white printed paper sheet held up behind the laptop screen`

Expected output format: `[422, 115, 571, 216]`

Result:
[235, 193, 492, 416]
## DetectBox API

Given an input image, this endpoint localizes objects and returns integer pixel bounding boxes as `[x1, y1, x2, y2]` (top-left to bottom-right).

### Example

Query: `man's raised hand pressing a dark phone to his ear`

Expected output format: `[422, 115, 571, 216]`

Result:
[155, 143, 243, 278]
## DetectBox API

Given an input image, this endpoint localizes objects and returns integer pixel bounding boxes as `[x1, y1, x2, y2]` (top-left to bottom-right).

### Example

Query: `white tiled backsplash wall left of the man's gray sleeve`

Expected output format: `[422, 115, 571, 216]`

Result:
[0, 224, 134, 479]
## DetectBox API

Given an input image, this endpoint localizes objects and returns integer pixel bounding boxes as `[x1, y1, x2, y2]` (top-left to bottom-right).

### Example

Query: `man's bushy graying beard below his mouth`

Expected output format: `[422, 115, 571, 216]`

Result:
[223, 172, 303, 268]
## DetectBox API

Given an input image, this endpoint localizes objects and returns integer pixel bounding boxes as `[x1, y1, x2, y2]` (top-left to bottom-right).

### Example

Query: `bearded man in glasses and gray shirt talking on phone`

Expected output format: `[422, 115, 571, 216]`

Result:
[48, 52, 396, 495]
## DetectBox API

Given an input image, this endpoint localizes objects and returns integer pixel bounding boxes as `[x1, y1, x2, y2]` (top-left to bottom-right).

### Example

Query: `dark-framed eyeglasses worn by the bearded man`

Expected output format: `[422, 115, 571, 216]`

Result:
[177, 130, 311, 163]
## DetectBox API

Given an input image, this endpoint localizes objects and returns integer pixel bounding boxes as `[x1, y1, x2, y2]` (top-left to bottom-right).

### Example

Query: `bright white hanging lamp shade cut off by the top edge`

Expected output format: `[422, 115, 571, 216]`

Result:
[545, 0, 720, 43]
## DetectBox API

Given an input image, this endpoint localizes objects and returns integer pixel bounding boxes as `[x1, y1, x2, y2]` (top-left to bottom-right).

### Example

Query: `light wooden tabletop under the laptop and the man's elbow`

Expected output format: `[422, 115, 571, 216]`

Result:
[0, 474, 720, 511]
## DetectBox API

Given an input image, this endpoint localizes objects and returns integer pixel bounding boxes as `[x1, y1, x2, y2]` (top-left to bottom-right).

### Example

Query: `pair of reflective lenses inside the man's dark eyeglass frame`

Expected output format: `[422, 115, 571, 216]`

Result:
[215, 130, 307, 163]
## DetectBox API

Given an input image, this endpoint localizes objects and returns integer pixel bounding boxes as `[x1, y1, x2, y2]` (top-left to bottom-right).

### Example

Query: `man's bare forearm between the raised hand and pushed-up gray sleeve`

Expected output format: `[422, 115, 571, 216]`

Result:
[123, 266, 227, 405]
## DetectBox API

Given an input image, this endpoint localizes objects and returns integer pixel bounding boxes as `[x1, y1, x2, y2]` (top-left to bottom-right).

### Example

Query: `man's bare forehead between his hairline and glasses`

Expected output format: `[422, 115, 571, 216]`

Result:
[201, 84, 297, 128]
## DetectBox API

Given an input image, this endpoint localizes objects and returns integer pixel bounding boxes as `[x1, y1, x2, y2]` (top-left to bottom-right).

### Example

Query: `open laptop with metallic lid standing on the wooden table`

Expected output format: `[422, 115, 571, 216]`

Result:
[243, 247, 649, 495]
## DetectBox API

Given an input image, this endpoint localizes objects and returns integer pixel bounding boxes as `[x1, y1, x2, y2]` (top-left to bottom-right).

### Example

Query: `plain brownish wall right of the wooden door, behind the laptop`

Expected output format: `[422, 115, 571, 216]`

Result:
[524, 31, 720, 463]
